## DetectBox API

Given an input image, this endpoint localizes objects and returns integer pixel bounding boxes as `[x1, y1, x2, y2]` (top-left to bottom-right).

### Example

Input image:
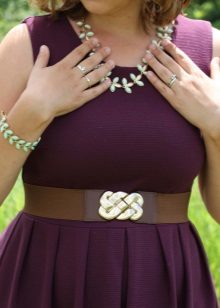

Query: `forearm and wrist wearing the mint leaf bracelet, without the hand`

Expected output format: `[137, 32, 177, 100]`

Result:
[0, 94, 52, 205]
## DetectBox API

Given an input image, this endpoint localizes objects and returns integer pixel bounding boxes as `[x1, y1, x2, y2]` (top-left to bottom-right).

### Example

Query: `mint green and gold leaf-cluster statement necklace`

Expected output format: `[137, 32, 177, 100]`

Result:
[76, 18, 175, 94]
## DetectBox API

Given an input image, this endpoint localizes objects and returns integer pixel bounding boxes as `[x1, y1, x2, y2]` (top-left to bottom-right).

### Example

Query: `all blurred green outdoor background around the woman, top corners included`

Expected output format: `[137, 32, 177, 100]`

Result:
[0, 0, 220, 299]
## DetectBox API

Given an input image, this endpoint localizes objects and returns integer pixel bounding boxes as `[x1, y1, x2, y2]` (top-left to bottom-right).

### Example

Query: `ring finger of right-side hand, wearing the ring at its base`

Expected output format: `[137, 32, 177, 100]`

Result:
[146, 51, 178, 83]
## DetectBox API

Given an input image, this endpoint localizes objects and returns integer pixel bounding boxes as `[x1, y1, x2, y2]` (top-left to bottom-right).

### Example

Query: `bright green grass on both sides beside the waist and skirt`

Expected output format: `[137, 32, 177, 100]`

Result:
[0, 176, 220, 299]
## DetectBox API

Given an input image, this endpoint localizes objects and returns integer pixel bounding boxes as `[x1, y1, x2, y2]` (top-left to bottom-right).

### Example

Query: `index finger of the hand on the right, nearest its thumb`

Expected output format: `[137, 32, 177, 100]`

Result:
[161, 40, 199, 74]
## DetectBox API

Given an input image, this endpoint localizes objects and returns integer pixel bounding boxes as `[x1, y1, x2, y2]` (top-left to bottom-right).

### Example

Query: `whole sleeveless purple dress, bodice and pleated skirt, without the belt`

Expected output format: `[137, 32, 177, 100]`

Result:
[0, 14, 217, 308]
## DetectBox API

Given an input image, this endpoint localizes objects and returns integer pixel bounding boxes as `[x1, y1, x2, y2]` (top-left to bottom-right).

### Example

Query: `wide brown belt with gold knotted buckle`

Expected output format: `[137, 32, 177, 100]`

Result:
[23, 183, 190, 223]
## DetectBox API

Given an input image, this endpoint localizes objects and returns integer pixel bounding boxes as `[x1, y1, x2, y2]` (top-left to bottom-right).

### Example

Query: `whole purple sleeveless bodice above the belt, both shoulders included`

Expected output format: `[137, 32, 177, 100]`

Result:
[23, 15, 211, 193]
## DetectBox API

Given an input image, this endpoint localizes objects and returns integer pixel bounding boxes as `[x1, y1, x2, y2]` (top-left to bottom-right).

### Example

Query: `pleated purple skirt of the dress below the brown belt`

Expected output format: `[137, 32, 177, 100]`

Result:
[0, 211, 217, 308]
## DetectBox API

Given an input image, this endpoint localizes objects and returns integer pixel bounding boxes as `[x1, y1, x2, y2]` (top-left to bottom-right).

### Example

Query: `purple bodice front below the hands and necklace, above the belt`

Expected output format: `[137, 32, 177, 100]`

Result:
[21, 71, 204, 193]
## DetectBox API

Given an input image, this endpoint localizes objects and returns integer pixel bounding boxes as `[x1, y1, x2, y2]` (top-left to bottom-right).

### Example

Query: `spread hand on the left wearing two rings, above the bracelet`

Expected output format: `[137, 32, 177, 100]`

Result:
[23, 39, 114, 120]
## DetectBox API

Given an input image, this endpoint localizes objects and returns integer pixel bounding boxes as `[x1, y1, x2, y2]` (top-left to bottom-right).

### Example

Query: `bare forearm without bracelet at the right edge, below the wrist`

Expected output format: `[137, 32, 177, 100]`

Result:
[199, 136, 220, 223]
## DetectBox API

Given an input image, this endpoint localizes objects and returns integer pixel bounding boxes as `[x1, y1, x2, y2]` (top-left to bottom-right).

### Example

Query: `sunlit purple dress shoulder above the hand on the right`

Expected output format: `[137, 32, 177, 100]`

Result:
[175, 15, 213, 76]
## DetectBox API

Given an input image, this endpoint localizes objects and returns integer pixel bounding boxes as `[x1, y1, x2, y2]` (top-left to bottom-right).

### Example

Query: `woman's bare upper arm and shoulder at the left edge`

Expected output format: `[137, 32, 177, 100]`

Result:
[0, 24, 34, 112]
